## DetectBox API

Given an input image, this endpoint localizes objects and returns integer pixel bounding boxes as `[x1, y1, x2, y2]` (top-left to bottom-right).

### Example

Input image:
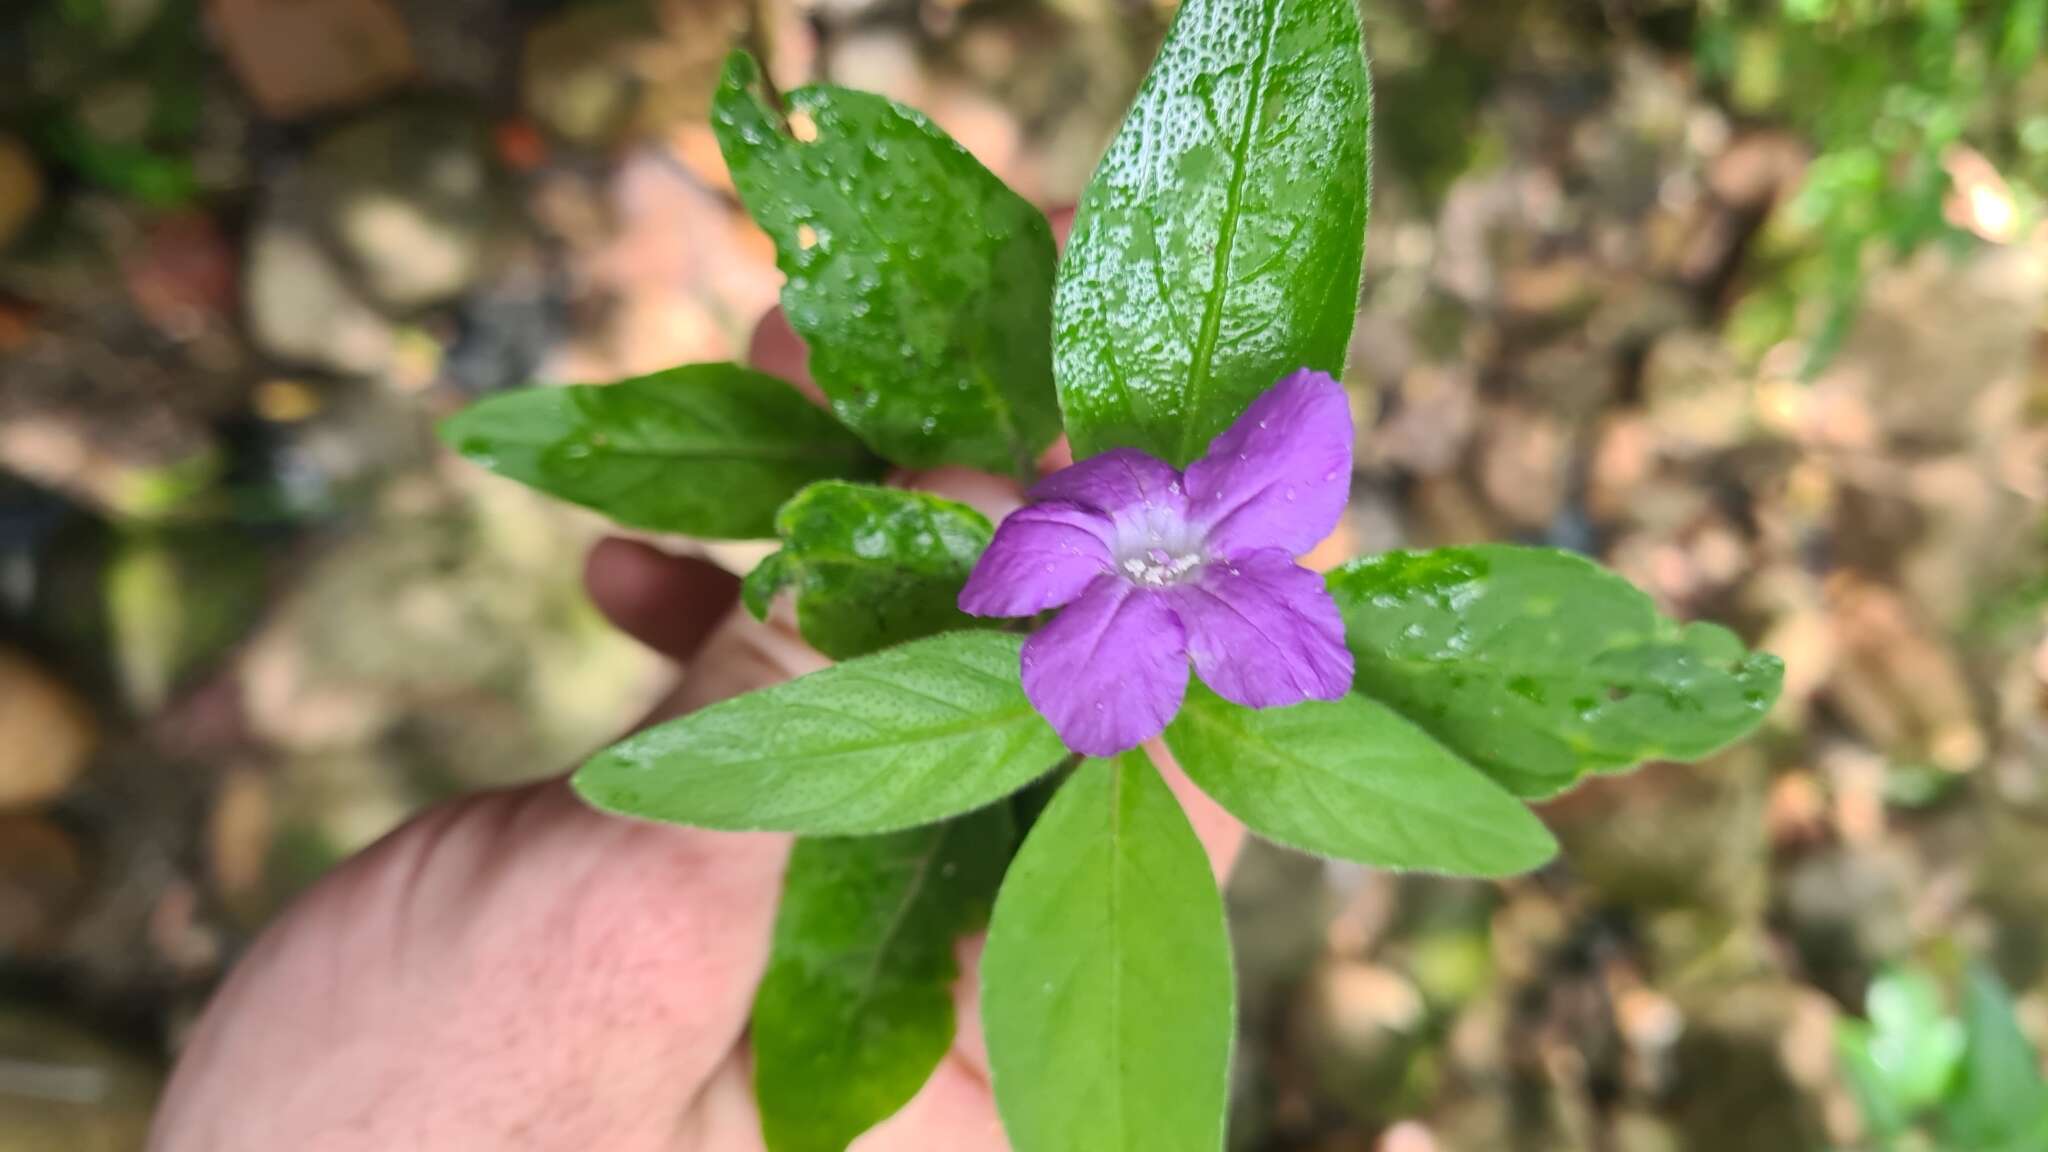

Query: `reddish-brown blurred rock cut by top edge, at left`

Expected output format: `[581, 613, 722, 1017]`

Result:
[209, 0, 414, 119]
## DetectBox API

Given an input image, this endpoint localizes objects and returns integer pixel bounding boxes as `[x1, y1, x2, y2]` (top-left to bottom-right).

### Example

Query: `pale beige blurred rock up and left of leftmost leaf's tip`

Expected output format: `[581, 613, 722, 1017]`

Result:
[244, 219, 397, 375]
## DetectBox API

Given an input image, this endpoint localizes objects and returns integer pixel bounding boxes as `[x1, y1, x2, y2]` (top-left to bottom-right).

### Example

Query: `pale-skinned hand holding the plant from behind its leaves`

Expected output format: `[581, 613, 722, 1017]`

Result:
[150, 301, 1243, 1152]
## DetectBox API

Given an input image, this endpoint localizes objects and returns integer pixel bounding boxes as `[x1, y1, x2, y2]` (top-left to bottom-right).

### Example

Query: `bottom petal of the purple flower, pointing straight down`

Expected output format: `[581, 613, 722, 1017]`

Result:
[1024, 576, 1188, 756]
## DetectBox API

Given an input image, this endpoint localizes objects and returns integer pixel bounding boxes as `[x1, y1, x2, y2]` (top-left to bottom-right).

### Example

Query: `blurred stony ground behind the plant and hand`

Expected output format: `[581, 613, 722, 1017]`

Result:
[0, 0, 2048, 1152]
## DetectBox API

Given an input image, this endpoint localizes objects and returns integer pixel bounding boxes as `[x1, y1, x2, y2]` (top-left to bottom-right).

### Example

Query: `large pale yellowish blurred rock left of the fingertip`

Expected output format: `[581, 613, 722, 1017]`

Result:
[242, 483, 655, 778]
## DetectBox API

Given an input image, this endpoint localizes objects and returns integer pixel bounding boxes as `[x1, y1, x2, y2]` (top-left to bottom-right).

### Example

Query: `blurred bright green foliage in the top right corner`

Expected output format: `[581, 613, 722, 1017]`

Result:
[1696, 0, 2048, 366]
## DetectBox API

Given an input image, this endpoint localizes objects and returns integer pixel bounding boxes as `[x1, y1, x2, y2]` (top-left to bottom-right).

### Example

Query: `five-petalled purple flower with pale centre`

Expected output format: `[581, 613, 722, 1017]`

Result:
[961, 371, 1352, 756]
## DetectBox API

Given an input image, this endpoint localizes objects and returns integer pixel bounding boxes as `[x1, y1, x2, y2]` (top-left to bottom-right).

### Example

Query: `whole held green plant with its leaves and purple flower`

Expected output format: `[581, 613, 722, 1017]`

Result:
[442, 0, 1782, 1152]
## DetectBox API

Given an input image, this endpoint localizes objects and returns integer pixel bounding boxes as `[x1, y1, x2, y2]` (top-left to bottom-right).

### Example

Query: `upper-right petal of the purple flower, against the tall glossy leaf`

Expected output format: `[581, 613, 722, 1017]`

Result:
[1188, 369, 1354, 556]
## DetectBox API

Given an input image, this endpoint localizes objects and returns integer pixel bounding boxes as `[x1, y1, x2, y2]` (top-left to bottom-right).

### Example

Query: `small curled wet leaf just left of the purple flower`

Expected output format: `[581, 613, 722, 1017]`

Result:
[745, 480, 995, 660]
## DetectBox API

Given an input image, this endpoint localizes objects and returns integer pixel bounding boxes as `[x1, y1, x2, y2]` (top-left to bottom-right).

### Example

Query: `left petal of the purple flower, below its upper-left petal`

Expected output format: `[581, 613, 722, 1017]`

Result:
[961, 504, 1112, 617]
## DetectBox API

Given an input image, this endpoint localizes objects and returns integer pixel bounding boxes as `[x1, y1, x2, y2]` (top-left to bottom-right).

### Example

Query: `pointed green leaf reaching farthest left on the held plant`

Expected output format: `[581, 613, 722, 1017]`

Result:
[440, 365, 881, 539]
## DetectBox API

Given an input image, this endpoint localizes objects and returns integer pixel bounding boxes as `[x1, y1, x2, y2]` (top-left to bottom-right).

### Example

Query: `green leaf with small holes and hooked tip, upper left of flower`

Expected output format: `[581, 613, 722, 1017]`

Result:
[713, 53, 1059, 476]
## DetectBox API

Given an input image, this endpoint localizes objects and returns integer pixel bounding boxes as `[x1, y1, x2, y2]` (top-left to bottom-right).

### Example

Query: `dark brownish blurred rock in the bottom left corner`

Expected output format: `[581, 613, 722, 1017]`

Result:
[0, 1004, 162, 1152]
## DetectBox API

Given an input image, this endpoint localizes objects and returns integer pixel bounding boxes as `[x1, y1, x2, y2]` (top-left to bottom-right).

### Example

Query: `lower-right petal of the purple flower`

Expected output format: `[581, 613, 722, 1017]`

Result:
[1167, 547, 1352, 707]
